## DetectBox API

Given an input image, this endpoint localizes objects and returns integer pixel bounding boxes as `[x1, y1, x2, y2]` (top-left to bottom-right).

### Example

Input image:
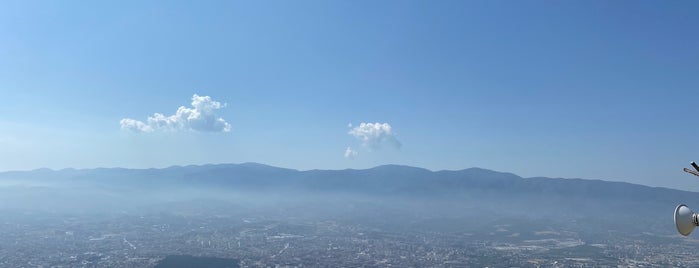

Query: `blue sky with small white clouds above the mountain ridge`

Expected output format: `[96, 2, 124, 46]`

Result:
[0, 0, 699, 190]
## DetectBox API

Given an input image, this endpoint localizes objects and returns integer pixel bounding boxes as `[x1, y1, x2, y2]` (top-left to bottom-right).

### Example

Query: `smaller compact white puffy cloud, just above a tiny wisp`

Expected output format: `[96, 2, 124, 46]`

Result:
[347, 123, 401, 149]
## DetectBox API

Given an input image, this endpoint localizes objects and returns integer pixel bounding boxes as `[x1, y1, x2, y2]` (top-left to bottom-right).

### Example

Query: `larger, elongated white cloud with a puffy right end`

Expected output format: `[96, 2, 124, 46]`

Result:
[119, 94, 231, 132]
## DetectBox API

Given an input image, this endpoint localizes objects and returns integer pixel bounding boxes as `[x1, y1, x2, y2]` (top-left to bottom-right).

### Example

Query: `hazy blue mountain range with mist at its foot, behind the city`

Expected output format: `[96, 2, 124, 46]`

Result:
[0, 163, 699, 236]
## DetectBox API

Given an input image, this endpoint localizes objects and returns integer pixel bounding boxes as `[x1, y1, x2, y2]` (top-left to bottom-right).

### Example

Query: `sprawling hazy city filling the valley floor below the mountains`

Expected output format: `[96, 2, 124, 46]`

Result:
[0, 208, 699, 267]
